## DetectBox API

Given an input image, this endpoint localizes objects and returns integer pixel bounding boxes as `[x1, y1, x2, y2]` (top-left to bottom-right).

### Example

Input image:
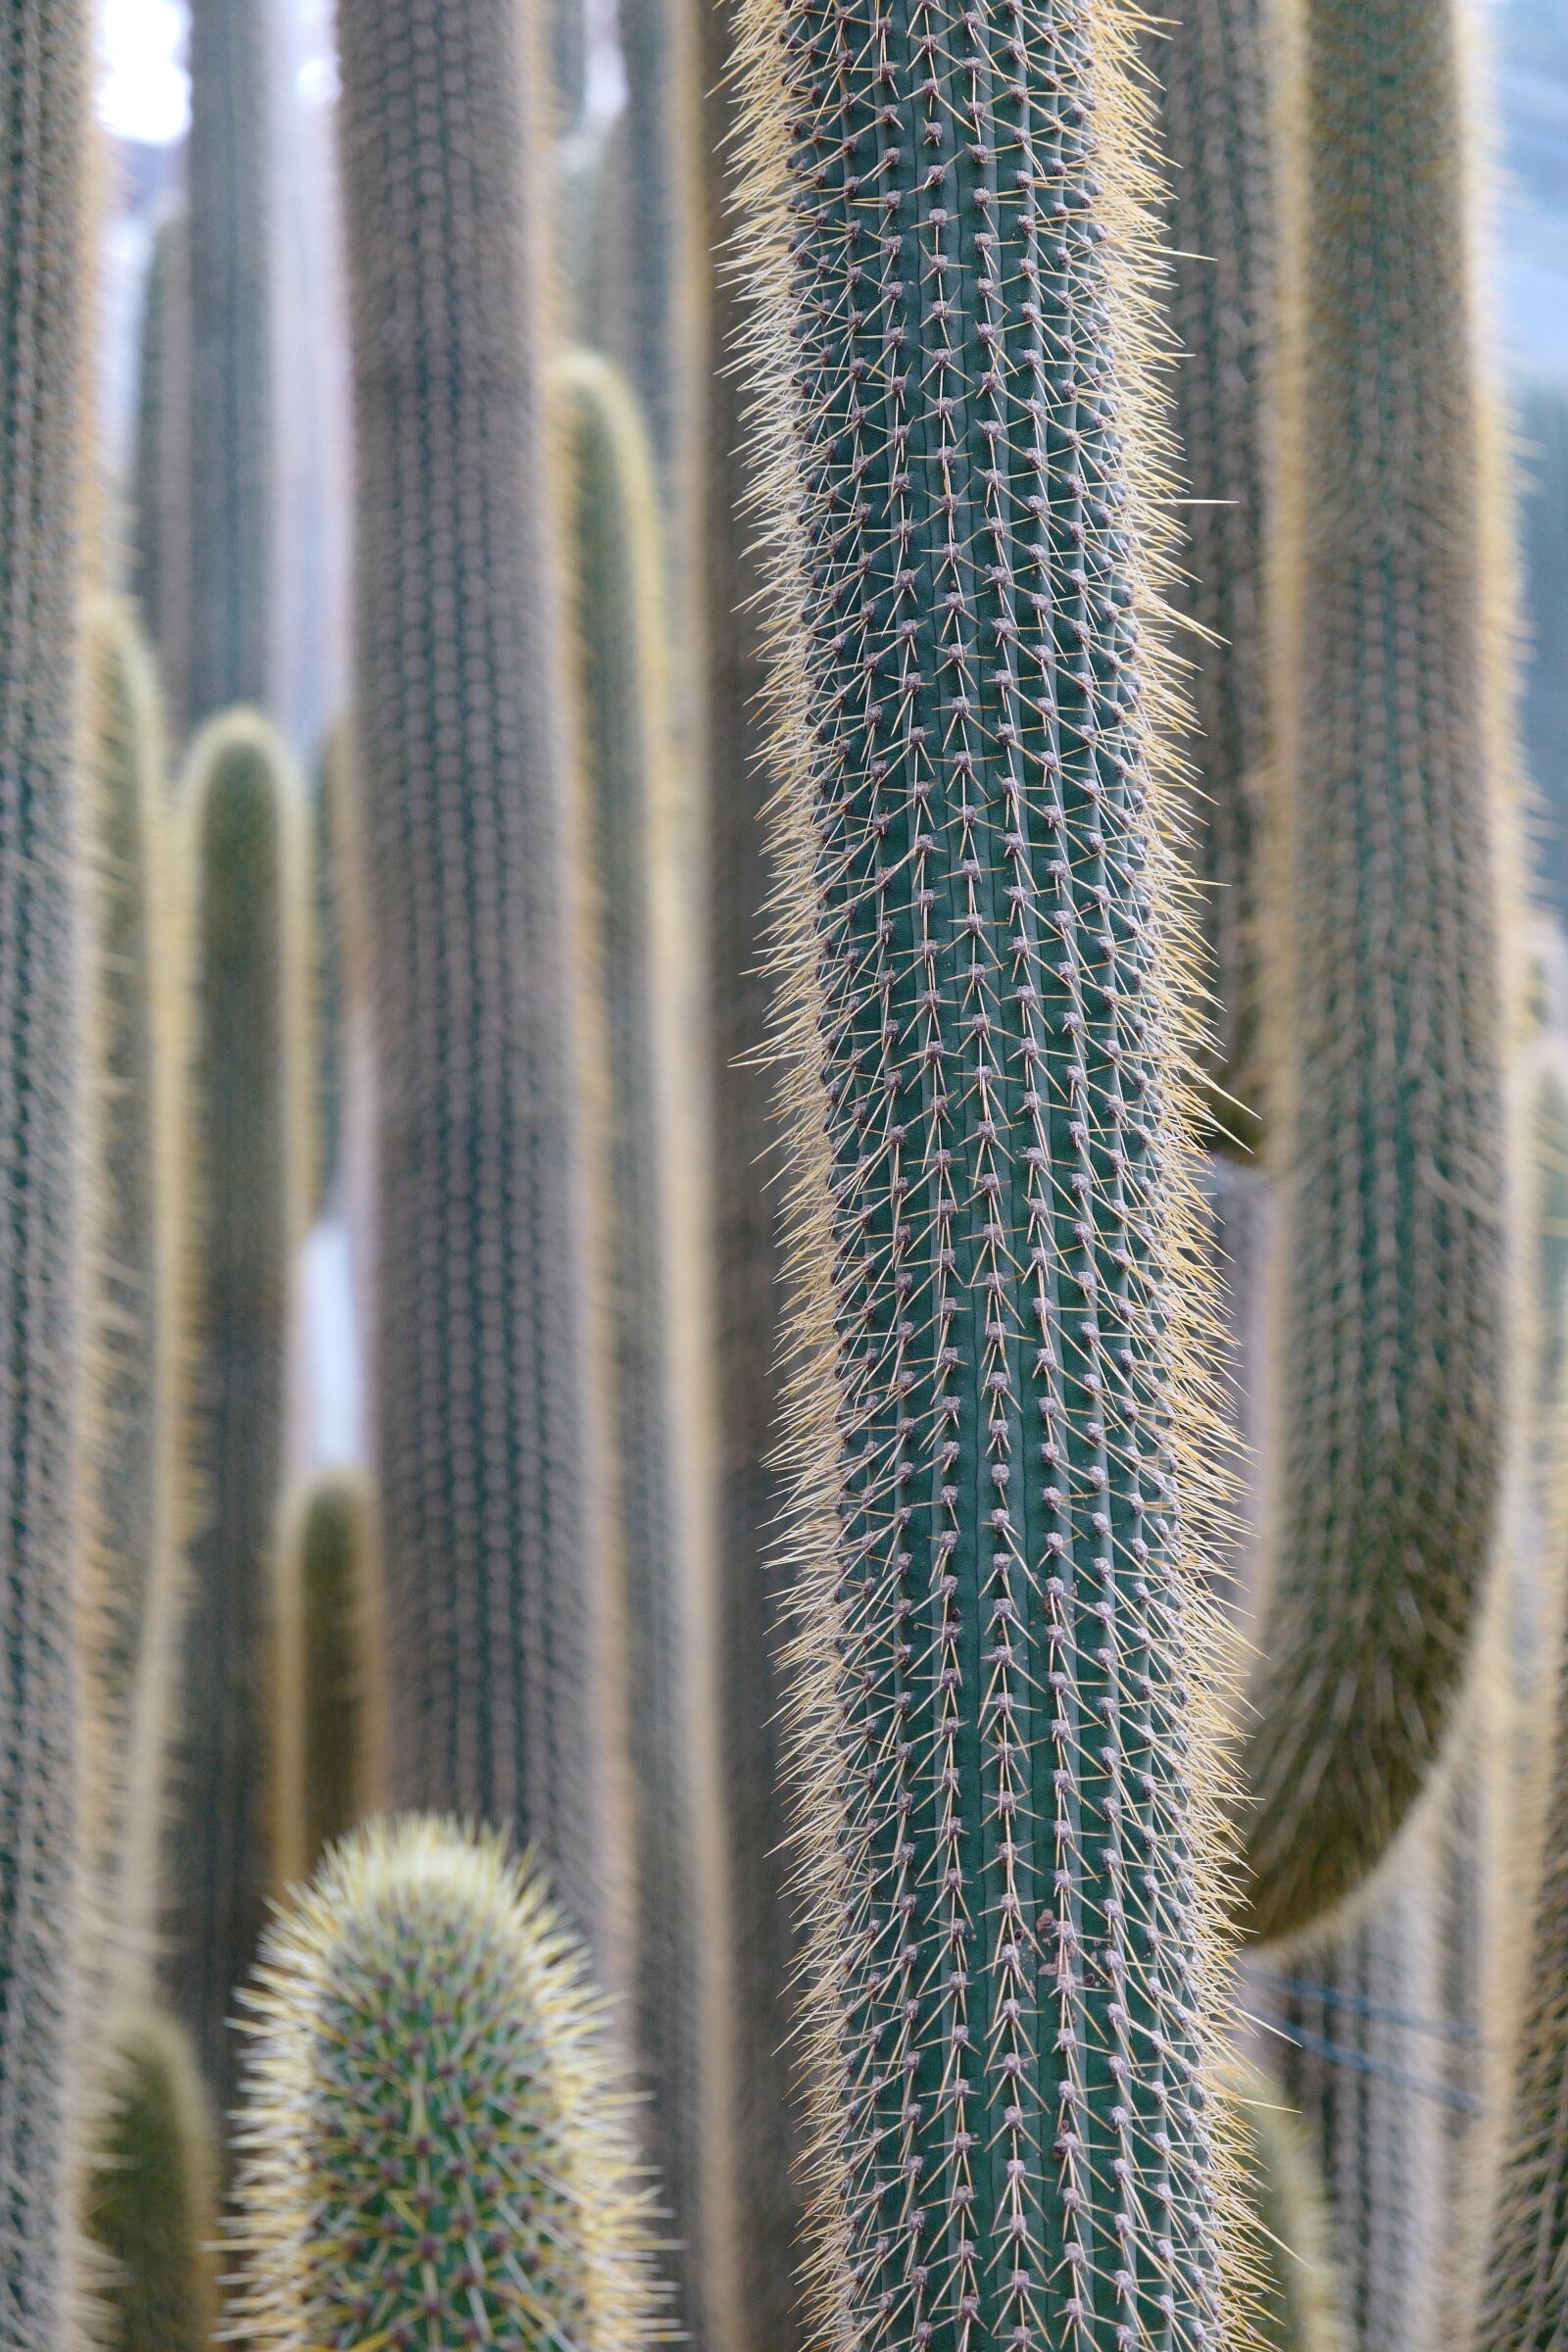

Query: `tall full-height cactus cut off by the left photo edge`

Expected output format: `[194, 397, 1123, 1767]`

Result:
[0, 0, 92, 2352]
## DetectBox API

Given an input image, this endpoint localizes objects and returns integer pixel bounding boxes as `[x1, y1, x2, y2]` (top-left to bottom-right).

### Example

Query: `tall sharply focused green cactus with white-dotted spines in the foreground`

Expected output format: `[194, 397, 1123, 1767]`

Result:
[748, 0, 1225, 2352]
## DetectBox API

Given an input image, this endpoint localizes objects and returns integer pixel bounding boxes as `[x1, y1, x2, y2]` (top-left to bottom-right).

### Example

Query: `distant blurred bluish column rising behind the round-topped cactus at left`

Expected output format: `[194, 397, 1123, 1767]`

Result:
[186, 0, 272, 724]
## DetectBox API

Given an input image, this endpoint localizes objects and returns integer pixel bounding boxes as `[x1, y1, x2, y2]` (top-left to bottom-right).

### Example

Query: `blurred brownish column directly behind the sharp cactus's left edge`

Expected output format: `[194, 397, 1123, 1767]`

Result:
[694, 0, 804, 2352]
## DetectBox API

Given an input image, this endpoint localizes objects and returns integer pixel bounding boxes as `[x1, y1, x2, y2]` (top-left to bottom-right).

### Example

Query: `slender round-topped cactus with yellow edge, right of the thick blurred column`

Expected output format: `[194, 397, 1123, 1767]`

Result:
[550, 351, 729, 2338]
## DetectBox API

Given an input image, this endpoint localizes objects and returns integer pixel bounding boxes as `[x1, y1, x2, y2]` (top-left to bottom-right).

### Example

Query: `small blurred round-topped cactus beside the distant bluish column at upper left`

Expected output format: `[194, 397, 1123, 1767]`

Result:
[129, 205, 190, 734]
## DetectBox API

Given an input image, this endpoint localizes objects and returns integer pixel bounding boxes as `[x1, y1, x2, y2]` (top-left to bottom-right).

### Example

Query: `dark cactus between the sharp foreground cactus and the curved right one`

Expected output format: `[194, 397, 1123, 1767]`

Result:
[1148, 0, 1272, 1148]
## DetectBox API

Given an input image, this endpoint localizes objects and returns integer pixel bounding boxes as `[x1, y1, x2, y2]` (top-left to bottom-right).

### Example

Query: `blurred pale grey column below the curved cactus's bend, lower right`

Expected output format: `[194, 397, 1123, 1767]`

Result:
[1265, 1833, 1452, 2352]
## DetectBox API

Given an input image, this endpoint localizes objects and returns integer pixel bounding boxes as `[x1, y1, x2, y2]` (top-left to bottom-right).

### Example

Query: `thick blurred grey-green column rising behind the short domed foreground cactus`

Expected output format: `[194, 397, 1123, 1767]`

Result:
[338, 0, 613, 1947]
